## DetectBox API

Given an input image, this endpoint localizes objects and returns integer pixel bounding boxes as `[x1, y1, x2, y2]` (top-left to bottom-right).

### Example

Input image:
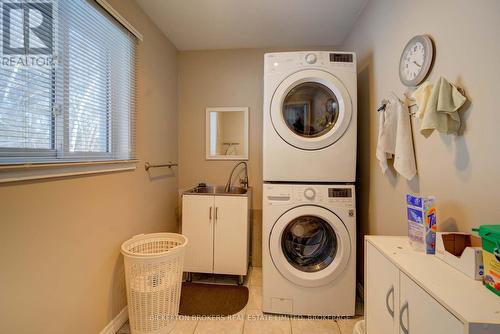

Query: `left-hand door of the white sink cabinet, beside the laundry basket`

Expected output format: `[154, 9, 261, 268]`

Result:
[182, 195, 215, 273]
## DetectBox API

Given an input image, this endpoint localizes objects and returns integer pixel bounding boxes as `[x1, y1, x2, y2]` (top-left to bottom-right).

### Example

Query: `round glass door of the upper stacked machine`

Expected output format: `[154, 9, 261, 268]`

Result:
[270, 69, 352, 150]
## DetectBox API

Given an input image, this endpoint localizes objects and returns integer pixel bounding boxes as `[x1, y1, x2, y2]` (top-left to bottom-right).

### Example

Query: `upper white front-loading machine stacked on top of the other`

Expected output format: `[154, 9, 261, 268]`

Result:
[263, 51, 357, 182]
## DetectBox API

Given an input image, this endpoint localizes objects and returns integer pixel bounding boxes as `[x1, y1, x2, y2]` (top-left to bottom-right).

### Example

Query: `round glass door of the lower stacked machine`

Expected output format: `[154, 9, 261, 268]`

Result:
[269, 205, 351, 287]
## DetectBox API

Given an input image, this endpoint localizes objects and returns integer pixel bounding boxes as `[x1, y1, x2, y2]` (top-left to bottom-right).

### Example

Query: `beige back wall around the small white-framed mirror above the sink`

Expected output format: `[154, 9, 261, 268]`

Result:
[178, 49, 264, 209]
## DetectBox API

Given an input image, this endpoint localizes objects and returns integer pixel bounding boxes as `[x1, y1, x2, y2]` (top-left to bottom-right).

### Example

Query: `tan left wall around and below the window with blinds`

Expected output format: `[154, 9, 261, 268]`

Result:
[0, 0, 178, 334]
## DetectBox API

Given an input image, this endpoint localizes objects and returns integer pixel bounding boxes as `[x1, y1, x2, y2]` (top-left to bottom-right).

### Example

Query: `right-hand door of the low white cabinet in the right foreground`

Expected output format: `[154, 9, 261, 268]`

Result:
[399, 273, 465, 334]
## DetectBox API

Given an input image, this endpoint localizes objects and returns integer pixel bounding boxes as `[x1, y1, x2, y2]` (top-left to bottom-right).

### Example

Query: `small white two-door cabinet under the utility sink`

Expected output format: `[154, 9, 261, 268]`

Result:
[182, 194, 250, 275]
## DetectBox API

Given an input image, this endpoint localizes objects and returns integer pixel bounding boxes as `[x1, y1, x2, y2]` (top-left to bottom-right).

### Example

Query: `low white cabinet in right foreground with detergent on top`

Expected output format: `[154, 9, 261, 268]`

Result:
[365, 236, 500, 334]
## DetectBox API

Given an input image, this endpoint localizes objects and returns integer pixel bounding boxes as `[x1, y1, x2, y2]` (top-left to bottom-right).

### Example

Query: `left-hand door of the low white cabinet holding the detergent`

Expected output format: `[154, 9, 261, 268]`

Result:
[365, 242, 399, 334]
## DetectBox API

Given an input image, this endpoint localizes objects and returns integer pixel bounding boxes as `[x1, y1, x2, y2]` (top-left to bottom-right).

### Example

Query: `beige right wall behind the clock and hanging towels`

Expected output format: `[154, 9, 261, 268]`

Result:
[342, 0, 500, 278]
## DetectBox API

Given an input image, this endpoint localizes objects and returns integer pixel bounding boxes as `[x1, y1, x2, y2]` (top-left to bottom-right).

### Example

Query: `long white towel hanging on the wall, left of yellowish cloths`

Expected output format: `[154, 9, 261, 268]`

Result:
[376, 96, 417, 180]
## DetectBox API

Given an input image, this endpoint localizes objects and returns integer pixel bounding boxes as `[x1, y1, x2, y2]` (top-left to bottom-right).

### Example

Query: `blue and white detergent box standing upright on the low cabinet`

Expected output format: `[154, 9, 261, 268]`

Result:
[406, 194, 437, 254]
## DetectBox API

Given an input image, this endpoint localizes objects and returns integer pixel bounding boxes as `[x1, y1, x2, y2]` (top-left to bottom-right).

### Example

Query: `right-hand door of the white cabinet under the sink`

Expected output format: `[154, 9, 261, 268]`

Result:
[214, 196, 248, 275]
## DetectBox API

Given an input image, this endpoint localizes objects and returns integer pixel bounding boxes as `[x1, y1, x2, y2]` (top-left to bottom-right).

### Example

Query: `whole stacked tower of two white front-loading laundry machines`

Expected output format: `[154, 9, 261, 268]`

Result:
[262, 51, 357, 316]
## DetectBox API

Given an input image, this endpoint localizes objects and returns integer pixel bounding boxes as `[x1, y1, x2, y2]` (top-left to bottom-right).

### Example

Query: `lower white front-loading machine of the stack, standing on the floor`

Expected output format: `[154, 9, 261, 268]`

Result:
[262, 183, 356, 316]
